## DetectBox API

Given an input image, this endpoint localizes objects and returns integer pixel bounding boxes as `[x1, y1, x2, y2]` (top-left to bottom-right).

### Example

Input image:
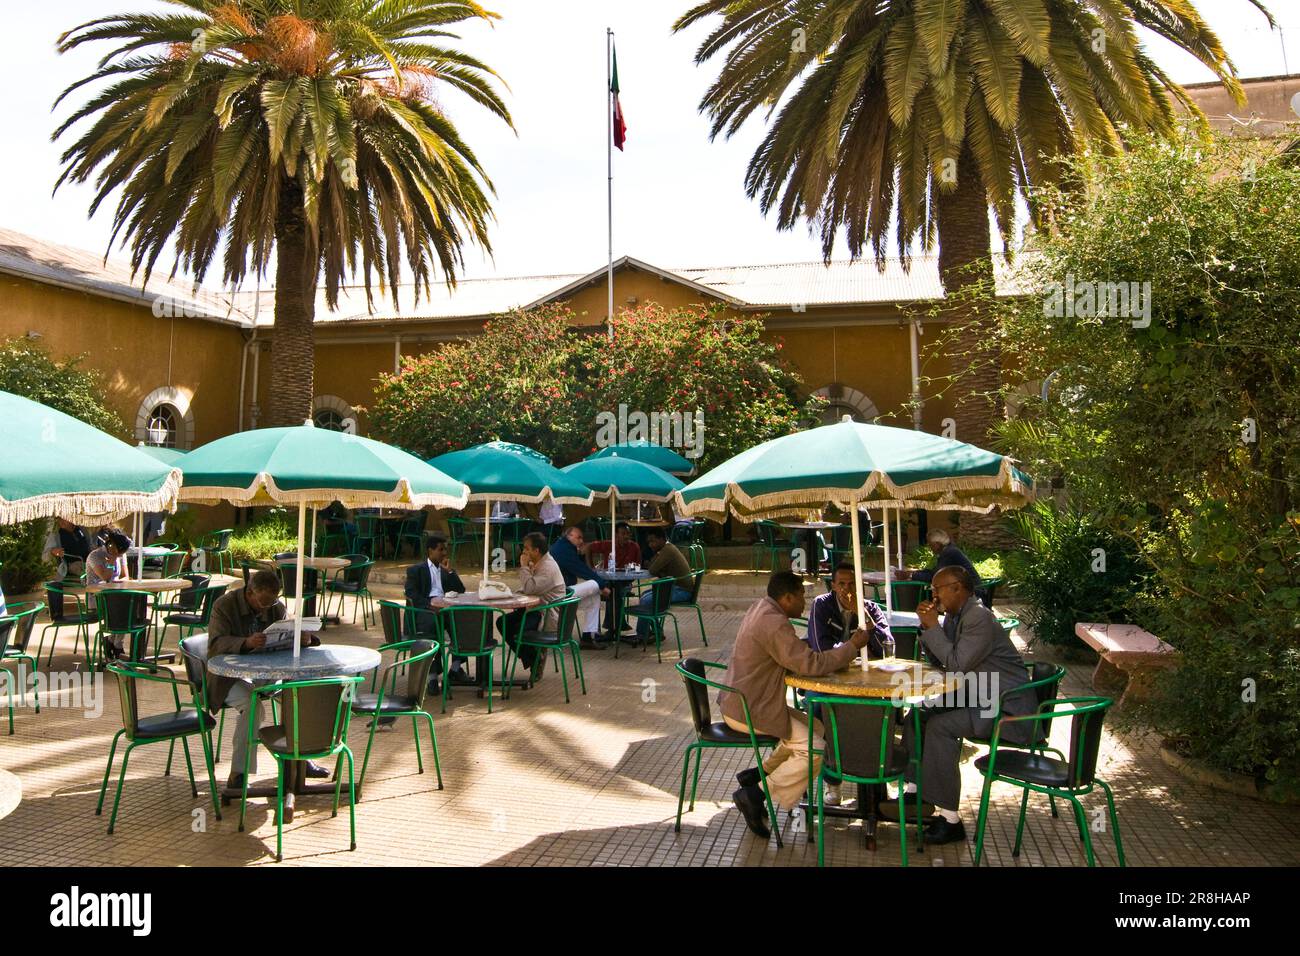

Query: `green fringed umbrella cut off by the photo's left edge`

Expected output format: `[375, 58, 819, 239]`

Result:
[0, 392, 181, 524]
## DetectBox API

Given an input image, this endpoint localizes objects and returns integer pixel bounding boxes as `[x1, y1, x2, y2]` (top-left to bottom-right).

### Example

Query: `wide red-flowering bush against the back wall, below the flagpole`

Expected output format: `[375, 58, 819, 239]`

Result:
[372, 304, 819, 468]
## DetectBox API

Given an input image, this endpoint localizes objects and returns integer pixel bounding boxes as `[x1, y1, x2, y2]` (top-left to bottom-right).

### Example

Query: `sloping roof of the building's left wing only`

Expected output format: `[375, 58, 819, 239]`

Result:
[0, 229, 248, 325]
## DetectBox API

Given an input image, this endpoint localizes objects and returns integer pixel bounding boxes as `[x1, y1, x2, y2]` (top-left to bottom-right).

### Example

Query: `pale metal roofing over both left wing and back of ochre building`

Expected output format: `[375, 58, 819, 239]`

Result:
[0, 229, 1014, 328]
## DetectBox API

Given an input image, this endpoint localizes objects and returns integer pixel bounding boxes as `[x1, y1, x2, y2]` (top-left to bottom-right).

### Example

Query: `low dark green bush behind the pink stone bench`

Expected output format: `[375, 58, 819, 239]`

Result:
[1008, 501, 1145, 646]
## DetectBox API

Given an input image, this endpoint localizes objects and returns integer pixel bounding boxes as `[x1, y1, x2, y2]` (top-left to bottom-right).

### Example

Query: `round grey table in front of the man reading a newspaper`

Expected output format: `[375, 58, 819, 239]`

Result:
[208, 644, 382, 822]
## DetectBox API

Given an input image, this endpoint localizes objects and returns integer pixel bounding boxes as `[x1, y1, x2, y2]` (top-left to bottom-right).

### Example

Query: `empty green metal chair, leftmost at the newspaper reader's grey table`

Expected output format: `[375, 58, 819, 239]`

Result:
[95, 662, 221, 834]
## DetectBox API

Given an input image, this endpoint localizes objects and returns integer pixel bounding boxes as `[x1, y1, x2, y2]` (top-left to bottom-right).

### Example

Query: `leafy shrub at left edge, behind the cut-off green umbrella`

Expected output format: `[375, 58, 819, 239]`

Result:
[0, 338, 127, 594]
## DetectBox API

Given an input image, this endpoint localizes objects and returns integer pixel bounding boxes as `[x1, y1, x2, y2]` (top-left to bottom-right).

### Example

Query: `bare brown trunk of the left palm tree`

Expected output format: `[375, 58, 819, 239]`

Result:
[267, 177, 316, 428]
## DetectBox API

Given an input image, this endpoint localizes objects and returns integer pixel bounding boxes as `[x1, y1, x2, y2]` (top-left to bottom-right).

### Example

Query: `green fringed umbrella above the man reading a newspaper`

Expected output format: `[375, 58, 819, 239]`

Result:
[181, 420, 469, 656]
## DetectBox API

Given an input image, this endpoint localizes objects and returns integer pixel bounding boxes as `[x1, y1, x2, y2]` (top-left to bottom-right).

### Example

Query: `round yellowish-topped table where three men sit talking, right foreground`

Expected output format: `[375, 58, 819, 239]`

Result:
[785, 658, 962, 852]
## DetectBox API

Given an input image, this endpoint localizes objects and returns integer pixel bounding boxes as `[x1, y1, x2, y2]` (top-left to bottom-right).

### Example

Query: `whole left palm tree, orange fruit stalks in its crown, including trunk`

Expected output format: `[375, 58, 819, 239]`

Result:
[55, 0, 511, 425]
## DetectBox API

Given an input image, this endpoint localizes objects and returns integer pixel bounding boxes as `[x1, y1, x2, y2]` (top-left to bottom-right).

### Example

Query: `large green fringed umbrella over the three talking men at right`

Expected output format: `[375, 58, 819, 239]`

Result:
[677, 416, 1034, 642]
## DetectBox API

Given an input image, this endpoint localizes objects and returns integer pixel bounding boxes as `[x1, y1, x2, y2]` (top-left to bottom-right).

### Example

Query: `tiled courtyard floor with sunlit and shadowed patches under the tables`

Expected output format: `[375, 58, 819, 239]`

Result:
[0, 574, 1300, 866]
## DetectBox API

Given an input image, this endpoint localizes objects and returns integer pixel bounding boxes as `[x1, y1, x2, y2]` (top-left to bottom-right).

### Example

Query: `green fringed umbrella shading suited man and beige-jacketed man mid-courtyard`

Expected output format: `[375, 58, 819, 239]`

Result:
[429, 441, 592, 579]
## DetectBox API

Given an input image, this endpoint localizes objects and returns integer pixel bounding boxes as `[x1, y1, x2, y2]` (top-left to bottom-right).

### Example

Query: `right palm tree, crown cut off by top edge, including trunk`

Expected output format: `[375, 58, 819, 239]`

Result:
[675, 0, 1273, 544]
